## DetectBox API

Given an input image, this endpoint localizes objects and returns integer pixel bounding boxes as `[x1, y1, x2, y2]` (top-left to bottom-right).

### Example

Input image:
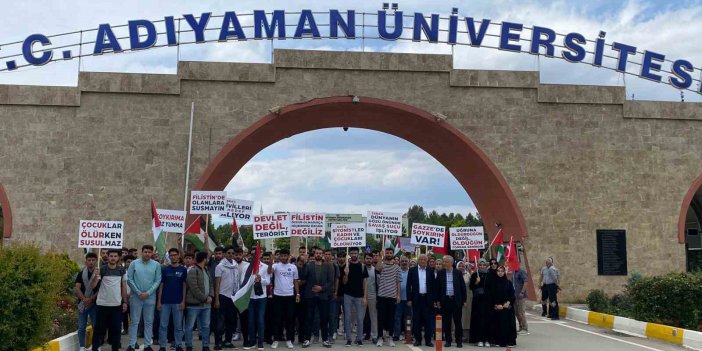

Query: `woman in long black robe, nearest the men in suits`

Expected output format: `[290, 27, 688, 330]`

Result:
[468, 258, 493, 347]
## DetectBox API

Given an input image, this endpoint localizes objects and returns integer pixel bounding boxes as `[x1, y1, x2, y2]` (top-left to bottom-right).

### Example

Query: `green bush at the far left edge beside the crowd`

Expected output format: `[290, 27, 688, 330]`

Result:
[0, 244, 73, 351]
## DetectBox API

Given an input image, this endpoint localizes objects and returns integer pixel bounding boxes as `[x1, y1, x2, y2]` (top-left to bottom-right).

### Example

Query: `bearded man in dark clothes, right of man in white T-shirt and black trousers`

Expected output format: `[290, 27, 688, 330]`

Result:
[300, 248, 334, 348]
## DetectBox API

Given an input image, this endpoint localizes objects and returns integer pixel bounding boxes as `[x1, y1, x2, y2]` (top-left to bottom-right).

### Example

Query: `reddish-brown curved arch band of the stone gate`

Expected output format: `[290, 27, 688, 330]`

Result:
[193, 96, 534, 286]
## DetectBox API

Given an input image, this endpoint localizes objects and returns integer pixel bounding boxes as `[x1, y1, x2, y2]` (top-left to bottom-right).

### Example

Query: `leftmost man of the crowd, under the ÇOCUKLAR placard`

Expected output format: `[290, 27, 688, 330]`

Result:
[73, 252, 97, 351]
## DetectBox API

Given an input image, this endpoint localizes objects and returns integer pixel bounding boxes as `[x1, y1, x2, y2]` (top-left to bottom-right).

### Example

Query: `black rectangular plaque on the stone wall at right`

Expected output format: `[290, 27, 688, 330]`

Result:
[597, 229, 627, 275]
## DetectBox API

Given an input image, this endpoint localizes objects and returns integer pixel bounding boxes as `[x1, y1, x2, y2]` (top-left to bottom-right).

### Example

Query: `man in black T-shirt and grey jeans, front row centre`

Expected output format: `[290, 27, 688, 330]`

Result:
[340, 247, 368, 346]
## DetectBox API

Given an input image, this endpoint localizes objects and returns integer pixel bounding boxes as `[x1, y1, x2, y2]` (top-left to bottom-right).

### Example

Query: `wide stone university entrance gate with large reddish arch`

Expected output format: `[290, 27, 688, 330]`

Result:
[0, 50, 702, 298]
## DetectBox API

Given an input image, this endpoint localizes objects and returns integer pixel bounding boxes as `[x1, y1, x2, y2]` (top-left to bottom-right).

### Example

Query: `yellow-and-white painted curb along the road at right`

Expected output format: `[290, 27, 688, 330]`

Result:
[533, 305, 702, 350]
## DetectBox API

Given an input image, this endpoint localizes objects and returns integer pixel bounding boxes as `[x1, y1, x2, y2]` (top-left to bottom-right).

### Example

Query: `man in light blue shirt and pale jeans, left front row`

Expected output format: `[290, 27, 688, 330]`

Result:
[127, 245, 161, 351]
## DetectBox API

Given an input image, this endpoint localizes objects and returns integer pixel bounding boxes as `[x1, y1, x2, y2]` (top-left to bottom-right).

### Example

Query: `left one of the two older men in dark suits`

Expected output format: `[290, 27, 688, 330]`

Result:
[407, 255, 434, 347]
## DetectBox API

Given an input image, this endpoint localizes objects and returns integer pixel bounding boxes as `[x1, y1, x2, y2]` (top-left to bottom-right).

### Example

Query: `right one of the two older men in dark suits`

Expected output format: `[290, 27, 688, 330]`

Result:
[434, 255, 467, 347]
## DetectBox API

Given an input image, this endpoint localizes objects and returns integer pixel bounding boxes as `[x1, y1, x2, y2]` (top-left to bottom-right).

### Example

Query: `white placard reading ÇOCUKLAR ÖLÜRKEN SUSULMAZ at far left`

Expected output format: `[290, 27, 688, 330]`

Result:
[78, 220, 124, 249]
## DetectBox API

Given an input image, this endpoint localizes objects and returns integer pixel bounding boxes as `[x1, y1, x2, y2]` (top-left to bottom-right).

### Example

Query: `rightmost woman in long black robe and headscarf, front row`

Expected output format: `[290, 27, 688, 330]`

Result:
[489, 266, 517, 347]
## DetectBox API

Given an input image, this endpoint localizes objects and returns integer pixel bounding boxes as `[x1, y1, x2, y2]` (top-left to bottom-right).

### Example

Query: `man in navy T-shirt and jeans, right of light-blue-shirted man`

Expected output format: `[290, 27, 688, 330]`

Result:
[156, 248, 188, 351]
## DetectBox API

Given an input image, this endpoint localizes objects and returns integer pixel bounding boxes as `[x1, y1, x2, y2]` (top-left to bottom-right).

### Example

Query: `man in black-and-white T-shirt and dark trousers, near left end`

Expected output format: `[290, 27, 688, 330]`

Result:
[90, 249, 128, 351]
